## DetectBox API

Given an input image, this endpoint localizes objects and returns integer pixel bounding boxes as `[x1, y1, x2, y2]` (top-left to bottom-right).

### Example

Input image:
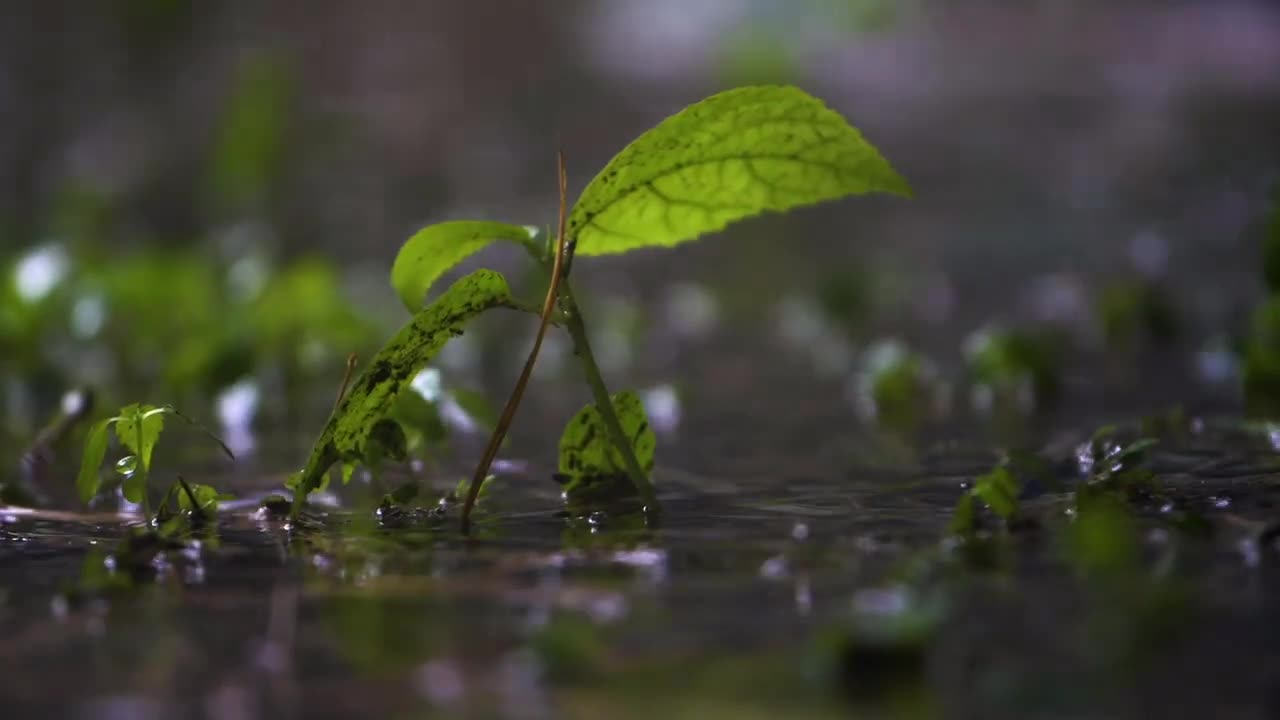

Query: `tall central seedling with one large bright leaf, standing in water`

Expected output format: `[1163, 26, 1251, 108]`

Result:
[289, 86, 911, 528]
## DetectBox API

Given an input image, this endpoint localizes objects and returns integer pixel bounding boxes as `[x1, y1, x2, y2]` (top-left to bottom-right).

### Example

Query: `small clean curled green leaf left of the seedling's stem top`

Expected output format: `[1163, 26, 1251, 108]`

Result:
[392, 220, 536, 313]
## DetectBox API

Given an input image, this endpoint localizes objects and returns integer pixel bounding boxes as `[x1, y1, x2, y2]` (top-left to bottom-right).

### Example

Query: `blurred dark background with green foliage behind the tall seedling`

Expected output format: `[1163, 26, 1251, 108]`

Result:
[0, 0, 1280, 476]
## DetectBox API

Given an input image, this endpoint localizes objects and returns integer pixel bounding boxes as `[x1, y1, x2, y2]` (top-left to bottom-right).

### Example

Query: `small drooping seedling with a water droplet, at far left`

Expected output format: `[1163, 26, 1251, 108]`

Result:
[76, 402, 236, 516]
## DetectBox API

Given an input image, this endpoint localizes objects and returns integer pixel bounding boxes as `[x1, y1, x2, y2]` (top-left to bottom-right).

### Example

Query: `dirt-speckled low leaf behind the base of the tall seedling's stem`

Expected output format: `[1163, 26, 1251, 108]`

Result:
[559, 391, 658, 478]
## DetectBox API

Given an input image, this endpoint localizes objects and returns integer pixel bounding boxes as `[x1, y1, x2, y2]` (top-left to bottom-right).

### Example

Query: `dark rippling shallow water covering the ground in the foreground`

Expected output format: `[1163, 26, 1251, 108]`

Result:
[0, 404, 1280, 717]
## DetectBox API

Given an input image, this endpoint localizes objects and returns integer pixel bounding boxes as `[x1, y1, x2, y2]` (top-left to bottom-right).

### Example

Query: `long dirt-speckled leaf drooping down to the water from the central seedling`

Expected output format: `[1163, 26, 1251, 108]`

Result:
[296, 270, 515, 498]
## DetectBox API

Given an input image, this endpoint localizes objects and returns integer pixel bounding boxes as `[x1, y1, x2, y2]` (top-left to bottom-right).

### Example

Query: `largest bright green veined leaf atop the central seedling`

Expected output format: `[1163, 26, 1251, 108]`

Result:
[567, 86, 911, 255]
